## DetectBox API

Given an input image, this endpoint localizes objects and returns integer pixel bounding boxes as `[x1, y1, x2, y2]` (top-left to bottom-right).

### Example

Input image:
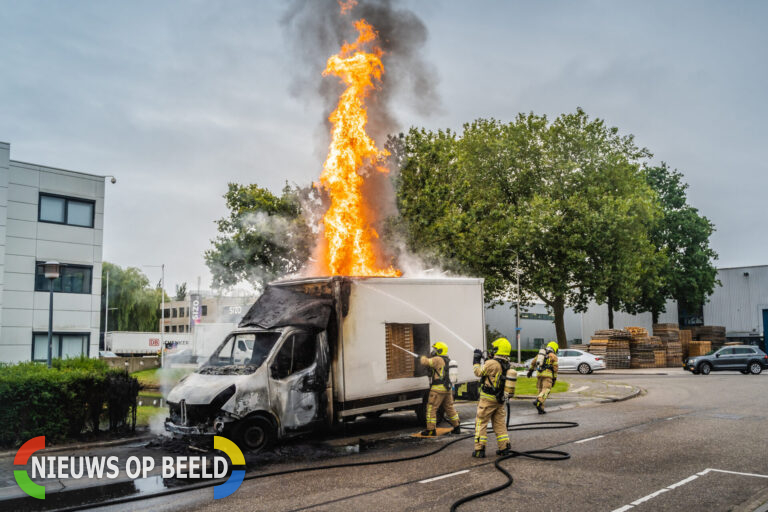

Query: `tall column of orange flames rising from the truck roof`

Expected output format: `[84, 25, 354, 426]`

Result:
[320, 15, 401, 277]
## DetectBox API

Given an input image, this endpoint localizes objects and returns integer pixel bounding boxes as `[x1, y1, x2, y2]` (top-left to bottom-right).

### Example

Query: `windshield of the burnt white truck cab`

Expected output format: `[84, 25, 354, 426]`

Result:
[198, 331, 281, 375]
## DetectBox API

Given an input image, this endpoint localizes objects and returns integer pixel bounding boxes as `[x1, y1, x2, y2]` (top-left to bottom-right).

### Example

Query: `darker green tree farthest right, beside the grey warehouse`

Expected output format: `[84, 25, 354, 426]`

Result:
[641, 162, 718, 323]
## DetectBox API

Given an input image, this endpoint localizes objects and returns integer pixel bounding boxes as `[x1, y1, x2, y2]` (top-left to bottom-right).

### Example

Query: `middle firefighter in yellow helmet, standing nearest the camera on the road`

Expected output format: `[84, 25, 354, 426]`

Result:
[472, 338, 517, 457]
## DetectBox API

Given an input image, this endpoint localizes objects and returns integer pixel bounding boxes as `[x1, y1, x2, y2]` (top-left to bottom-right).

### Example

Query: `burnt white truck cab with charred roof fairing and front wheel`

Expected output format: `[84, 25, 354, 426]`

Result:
[165, 287, 333, 451]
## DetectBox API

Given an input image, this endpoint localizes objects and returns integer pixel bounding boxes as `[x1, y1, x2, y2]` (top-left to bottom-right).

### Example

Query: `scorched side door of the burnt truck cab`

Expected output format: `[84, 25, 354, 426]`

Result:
[270, 331, 328, 430]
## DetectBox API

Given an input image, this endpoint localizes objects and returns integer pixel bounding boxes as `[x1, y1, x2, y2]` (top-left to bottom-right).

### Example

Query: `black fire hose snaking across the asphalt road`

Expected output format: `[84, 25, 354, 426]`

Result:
[54, 421, 579, 512]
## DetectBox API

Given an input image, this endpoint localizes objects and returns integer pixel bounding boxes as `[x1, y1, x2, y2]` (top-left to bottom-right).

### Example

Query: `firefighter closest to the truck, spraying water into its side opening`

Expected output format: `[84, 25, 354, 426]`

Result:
[419, 341, 461, 437]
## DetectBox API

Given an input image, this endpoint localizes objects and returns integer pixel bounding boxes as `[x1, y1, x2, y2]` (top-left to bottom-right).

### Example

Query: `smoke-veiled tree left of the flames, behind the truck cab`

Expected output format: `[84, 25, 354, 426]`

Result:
[205, 183, 313, 287]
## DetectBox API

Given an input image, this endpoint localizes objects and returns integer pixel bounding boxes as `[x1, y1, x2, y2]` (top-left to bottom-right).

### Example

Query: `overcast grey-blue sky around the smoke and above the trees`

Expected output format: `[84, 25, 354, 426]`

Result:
[0, 0, 768, 292]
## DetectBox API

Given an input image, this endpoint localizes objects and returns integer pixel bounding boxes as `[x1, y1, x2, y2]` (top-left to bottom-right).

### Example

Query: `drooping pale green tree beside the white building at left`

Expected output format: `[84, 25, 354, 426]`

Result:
[101, 261, 167, 332]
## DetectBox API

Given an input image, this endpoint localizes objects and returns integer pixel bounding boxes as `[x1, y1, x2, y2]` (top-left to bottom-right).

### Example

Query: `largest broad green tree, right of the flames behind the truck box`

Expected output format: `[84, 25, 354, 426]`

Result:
[390, 109, 656, 346]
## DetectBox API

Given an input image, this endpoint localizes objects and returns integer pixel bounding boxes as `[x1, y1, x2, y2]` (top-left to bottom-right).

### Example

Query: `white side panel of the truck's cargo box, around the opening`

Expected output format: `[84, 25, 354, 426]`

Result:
[334, 278, 485, 401]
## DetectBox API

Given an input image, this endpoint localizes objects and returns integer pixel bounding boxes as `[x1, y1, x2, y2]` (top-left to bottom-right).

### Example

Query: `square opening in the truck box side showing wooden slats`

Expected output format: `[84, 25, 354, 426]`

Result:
[384, 324, 429, 379]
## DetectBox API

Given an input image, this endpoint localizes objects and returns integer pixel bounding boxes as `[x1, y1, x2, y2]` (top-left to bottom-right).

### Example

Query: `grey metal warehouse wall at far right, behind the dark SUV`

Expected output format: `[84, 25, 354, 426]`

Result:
[704, 265, 768, 335]
